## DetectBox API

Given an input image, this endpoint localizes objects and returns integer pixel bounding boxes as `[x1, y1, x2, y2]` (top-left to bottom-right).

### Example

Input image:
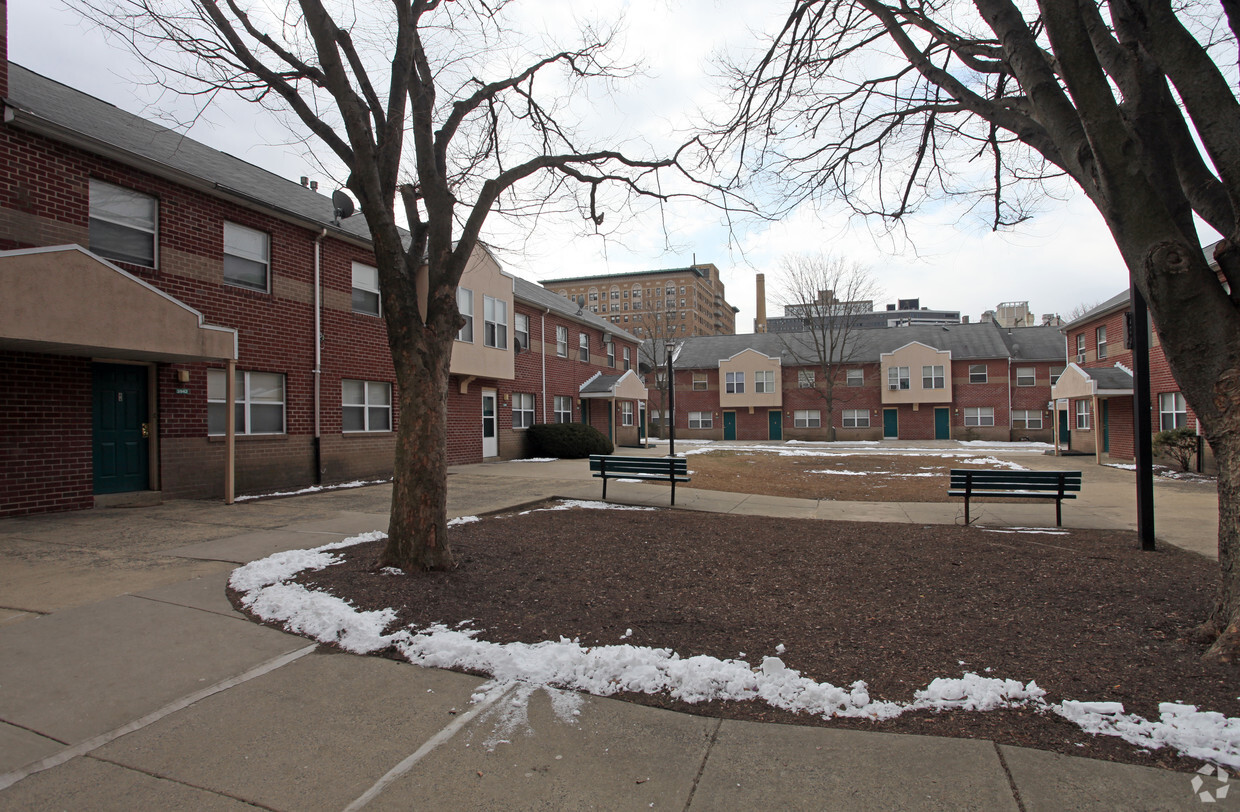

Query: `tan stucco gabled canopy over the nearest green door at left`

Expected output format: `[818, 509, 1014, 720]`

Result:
[0, 245, 237, 362]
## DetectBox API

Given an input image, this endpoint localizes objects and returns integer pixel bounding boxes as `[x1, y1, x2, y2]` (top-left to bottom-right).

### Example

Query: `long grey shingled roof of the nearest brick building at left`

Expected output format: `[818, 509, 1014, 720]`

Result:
[9, 63, 370, 242]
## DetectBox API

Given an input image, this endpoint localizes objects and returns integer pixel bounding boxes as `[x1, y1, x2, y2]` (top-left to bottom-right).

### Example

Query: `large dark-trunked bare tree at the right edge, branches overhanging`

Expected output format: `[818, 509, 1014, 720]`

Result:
[727, 0, 1240, 661]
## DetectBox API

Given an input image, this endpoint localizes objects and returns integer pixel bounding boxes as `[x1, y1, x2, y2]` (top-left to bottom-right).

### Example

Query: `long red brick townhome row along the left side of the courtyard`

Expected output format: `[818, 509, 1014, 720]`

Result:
[0, 23, 645, 516]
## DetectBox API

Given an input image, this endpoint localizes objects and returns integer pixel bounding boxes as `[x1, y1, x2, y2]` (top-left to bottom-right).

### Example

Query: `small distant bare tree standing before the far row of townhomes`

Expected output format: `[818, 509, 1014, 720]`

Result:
[775, 254, 882, 440]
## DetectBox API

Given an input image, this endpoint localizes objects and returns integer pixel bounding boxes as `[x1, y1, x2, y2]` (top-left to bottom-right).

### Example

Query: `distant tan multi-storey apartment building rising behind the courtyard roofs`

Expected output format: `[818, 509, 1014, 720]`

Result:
[542, 263, 739, 340]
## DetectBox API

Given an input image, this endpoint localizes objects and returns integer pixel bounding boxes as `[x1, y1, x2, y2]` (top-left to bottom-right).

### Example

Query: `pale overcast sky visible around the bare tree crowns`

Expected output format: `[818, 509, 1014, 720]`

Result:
[9, 0, 1145, 332]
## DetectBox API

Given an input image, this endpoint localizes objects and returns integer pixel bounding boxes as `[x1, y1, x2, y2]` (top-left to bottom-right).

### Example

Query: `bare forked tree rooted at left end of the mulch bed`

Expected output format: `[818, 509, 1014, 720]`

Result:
[87, 0, 719, 571]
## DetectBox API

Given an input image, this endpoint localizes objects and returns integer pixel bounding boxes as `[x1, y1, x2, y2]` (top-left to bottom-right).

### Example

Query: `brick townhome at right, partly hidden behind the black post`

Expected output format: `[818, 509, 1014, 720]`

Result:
[1052, 290, 1213, 466]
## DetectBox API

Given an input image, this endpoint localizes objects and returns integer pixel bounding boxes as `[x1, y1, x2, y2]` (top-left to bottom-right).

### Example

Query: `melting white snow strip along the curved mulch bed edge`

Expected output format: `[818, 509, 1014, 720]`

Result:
[228, 518, 1240, 770]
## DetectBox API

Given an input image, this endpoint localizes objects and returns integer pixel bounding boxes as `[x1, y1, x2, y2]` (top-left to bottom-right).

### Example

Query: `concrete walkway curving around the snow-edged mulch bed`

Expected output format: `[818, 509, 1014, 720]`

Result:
[0, 451, 1220, 811]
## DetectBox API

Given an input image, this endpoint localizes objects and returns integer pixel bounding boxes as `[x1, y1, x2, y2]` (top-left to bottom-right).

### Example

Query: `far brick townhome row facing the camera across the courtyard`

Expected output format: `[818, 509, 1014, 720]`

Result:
[659, 322, 1064, 443]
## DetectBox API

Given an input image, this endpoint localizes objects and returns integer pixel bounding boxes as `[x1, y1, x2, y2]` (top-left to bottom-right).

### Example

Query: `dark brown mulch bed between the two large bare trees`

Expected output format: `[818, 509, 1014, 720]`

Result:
[274, 510, 1240, 770]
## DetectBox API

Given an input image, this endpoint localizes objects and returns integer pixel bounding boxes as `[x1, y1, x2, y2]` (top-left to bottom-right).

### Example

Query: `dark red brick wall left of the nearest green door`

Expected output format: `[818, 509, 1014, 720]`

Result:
[0, 351, 94, 517]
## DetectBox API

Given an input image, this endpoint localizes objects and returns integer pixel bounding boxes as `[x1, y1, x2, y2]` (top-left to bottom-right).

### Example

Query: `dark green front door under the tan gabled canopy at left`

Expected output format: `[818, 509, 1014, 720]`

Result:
[91, 363, 150, 493]
